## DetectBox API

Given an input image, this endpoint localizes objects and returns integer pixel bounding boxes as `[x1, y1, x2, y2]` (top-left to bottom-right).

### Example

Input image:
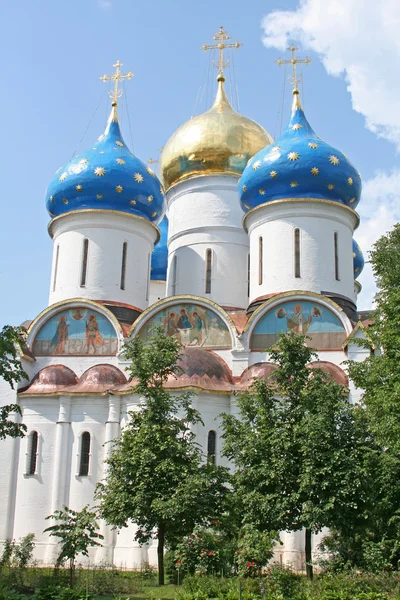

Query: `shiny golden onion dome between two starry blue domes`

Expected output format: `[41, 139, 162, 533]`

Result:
[160, 75, 273, 189]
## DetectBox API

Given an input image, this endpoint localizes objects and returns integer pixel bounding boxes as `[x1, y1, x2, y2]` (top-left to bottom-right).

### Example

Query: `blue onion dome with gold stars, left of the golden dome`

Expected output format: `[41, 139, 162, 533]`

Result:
[46, 106, 164, 223]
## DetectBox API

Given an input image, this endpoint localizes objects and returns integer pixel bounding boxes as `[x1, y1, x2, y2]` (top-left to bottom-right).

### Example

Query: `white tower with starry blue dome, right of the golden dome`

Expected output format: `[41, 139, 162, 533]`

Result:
[239, 89, 361, 313]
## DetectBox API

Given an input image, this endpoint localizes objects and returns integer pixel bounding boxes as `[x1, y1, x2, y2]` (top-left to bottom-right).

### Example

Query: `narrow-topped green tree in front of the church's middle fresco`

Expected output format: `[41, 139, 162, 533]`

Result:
[97, 328, 228, 585]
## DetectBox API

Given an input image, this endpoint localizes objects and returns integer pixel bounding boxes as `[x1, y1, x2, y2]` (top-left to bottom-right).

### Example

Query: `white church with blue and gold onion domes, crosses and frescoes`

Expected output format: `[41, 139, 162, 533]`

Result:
[0, 28, 368, 569]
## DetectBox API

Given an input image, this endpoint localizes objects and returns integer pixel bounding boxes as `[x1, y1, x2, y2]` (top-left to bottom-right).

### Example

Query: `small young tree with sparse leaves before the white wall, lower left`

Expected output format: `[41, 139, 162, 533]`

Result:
[44, 506, 103, 587]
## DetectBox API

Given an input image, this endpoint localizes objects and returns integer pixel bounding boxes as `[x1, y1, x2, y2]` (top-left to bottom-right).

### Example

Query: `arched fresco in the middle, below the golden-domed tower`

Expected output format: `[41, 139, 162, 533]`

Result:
[139, 303, 231, 348]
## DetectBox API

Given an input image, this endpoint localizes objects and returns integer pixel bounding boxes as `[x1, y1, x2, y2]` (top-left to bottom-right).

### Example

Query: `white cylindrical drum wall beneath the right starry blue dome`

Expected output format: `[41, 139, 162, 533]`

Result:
[245, 201, 357, 302]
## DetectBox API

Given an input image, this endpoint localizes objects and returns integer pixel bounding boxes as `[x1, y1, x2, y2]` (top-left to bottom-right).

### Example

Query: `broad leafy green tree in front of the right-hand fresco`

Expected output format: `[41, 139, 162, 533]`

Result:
[223, 333, 370, 577]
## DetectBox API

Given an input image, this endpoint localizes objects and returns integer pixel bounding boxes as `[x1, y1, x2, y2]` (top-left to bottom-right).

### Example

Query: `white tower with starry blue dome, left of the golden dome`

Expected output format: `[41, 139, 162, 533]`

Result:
[46, 102, 164, 310]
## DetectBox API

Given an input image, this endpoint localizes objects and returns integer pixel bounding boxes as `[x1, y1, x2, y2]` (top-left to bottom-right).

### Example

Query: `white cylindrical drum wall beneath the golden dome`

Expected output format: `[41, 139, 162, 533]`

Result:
[167, 176, 249, 308]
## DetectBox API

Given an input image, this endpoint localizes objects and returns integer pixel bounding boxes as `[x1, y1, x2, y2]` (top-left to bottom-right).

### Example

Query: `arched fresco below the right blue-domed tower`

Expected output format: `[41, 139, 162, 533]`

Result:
[250, 300, 346, 350]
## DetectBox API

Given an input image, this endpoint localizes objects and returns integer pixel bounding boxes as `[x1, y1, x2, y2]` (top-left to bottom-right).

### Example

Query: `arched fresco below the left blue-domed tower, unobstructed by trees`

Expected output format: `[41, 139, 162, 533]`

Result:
[32, 307, 118, 356]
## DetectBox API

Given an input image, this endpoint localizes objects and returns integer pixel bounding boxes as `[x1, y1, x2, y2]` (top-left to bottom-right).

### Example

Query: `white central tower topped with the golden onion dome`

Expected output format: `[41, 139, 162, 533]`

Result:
[160, 74, 272, 308]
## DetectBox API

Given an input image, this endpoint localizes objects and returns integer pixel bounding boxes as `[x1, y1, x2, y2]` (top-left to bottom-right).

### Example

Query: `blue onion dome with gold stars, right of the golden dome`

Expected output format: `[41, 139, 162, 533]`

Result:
[239, 91, 361, 212]
